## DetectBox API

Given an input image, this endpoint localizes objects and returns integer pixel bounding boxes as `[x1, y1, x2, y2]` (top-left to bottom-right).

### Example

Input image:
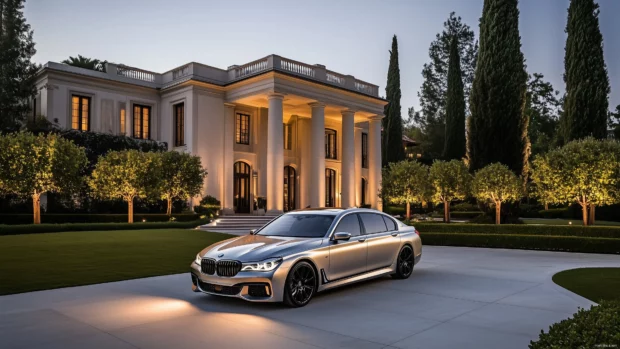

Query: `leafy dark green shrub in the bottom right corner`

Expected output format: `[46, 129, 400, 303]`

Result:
[529, 301, 620, 349]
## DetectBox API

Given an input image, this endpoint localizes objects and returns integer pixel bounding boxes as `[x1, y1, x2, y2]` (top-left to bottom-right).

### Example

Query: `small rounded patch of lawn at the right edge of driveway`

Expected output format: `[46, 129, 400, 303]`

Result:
[553, 268, 620, 303]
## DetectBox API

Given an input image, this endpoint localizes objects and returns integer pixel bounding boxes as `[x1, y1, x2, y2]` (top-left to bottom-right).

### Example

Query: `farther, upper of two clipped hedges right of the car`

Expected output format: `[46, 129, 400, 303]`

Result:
[411, 222, 620, 238]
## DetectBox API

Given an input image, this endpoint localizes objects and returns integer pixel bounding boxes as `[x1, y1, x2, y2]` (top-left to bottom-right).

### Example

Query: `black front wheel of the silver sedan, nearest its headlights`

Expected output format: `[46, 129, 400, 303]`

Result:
[284, 261, 317, 308]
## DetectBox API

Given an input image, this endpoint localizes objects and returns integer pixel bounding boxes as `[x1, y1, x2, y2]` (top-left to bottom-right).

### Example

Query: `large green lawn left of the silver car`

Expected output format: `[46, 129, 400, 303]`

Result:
[0, 229, 231, 295]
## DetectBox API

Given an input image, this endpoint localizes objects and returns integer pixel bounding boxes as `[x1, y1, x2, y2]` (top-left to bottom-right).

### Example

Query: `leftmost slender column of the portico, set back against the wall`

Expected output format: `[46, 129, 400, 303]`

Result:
[222, 103, 235, 215]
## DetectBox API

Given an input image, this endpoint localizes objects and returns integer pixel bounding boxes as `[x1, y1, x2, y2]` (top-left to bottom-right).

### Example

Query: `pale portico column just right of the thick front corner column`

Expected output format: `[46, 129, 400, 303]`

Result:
[310, 102, 325, 208]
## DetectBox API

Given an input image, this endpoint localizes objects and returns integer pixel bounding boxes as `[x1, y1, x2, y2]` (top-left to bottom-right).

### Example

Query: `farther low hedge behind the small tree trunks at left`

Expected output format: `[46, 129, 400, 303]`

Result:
[0, 213, 200, 224]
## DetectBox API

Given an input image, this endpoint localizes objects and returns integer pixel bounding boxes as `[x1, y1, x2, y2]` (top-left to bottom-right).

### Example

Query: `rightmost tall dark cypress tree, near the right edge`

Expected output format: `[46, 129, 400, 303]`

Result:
[563, 0, 610, 142]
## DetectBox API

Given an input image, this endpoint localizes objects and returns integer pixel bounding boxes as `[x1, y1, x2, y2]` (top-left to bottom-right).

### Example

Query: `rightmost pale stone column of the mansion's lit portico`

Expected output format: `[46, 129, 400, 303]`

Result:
[368, 115, 383, 210]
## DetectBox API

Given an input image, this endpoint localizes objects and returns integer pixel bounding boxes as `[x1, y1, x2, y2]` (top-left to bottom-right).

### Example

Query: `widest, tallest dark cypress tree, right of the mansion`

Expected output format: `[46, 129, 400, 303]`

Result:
[467, 0, 530, 175]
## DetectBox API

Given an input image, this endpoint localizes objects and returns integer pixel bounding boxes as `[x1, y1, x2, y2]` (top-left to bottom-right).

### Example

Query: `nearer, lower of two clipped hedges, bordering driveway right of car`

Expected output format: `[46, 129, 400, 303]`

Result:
[420, 232, 620, 254]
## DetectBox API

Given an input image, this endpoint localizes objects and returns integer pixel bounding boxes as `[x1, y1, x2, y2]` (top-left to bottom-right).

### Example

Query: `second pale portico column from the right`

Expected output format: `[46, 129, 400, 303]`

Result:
[340, 109, 355, 208]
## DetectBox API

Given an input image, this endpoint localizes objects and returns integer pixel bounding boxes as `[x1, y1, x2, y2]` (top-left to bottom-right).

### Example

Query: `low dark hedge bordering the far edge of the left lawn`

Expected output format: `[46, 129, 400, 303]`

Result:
[0, 219, 209, 236]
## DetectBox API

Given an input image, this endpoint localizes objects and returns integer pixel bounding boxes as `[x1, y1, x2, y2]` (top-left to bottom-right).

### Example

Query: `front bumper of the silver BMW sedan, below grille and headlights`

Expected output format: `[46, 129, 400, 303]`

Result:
[191, 262, 288, 302]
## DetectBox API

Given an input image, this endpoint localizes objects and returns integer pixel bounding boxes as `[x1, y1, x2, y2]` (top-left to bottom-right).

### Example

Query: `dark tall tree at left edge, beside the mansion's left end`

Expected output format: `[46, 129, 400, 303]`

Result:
[0, 0, 39, 130]
